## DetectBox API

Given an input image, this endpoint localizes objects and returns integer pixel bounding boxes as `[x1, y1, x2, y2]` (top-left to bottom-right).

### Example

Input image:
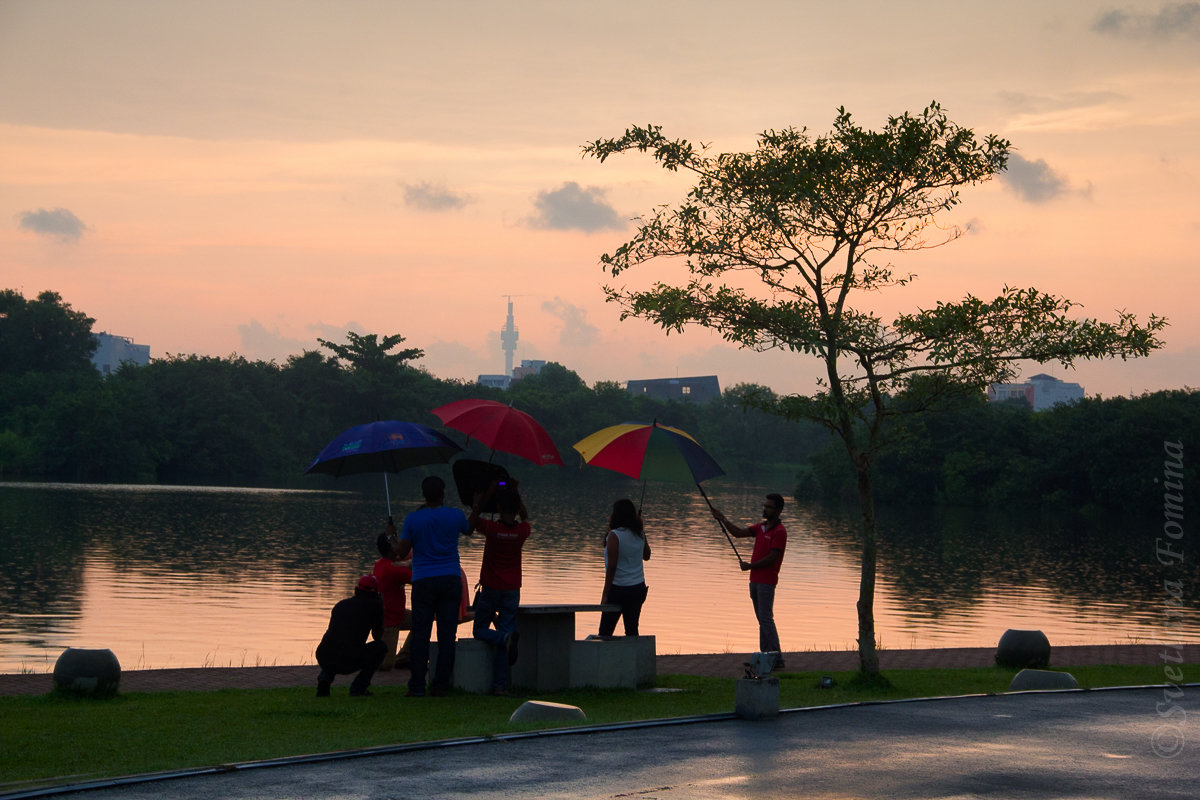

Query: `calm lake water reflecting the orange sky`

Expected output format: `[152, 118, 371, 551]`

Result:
[0, 479, 1200, 672]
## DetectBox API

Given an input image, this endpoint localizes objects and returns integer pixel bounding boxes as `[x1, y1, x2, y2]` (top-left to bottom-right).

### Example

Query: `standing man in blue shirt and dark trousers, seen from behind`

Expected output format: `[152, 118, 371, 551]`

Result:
[396, 475, 470, 697]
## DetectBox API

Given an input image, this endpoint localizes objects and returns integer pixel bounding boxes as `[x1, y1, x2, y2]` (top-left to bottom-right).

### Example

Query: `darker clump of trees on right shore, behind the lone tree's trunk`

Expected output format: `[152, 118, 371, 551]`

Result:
[797, 389, 1200, 515]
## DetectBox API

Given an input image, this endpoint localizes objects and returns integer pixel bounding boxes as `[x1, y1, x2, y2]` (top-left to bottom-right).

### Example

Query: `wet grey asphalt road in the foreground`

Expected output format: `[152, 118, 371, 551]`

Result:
[44, 686, 1200, 800]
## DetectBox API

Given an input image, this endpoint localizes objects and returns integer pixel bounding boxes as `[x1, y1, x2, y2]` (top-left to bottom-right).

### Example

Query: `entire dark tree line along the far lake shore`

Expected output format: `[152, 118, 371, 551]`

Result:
[7, 290, 1200, 510]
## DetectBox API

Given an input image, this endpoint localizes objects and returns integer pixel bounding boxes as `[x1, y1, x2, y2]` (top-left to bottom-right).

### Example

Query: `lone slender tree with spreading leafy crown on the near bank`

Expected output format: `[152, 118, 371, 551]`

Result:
[584, 103, 1165, 680]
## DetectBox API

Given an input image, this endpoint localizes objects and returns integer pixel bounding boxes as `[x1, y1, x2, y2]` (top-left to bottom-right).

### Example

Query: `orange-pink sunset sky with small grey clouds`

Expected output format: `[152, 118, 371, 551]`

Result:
[0, 0, 1200, 396]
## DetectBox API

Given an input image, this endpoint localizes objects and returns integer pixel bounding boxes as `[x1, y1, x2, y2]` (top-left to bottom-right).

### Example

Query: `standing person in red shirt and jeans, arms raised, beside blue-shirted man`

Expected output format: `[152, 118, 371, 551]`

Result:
[469, 482, 532, 694]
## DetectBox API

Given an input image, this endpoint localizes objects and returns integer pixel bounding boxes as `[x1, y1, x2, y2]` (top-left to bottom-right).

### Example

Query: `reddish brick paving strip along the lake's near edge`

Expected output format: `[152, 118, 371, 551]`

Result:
[0, 644, 1200, 696]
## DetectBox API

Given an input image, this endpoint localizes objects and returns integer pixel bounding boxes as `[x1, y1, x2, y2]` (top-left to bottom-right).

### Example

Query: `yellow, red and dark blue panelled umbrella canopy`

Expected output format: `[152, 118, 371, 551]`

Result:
[574, 422, 725, 483]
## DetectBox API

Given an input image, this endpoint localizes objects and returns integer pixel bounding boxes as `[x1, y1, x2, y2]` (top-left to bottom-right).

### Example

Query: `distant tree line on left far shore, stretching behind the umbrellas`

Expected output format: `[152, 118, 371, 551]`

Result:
[0, 290, 828, 487]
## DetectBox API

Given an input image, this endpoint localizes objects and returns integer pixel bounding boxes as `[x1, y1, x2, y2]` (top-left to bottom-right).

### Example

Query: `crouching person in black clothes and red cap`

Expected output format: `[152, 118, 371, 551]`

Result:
[317, 575, 385, 697]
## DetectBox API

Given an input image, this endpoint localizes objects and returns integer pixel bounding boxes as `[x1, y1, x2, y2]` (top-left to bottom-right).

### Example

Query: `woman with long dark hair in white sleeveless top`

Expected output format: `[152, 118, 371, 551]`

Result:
[600, 499, 650, 636]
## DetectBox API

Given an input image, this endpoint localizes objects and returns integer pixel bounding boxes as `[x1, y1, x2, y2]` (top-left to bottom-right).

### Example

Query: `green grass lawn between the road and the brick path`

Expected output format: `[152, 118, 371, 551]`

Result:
[0, 664, 1180, 793]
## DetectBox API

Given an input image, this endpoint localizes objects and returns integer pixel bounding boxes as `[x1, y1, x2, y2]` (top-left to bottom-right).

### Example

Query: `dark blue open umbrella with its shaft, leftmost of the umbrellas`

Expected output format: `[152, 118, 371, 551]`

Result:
[305, 420, 462, 517]
